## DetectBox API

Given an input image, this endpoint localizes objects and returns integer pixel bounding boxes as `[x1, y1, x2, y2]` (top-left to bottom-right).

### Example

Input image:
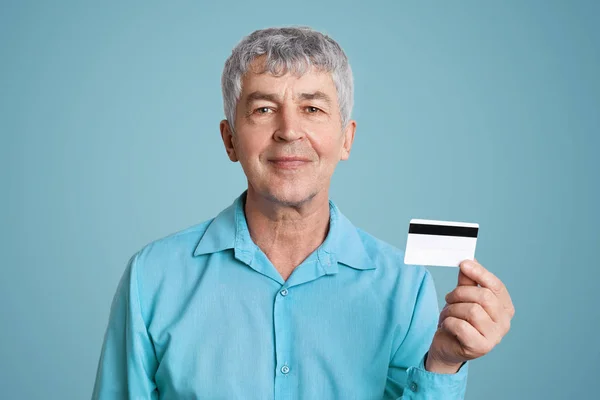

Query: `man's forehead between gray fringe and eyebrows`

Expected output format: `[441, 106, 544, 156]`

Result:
[240, 58, 337, 101]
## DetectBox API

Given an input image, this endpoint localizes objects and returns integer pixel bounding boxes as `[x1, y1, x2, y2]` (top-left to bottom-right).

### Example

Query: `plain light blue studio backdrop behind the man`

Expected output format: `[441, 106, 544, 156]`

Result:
[0, 0, 600, 400]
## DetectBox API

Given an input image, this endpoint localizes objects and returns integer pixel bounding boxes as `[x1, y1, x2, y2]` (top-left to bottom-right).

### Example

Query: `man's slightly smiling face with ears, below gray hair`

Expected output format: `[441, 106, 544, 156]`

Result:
[221, 58, 356, 206]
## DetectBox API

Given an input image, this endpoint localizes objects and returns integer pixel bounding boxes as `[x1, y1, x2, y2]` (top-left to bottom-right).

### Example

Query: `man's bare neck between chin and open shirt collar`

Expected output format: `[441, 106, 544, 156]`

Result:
[244, 187, 329, 276]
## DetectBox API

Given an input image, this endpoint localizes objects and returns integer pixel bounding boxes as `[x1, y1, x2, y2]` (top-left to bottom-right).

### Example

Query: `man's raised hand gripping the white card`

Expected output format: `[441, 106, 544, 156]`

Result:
[425, 260, 515, 374]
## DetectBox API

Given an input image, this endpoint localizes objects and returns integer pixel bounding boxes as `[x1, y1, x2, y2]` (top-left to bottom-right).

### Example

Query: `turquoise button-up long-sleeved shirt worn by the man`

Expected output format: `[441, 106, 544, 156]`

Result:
[93, 193, 468, 400]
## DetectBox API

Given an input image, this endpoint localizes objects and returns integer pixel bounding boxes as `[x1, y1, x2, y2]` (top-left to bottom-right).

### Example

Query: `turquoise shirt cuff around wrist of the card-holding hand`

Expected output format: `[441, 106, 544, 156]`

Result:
[402, 353, 469, 400]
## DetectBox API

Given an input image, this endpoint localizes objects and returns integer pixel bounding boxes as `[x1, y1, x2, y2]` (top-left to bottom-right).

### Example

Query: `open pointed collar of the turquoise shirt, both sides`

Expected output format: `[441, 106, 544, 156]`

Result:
[194, 191, 376, 273]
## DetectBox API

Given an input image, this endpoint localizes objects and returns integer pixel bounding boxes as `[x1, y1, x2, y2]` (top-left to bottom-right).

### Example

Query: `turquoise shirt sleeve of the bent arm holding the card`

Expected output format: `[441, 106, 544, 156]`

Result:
[384, 271, 469, 400]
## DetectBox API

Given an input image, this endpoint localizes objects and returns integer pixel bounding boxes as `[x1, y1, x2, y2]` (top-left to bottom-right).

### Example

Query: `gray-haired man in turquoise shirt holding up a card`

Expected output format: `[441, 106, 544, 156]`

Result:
[93, 28, 514, 400]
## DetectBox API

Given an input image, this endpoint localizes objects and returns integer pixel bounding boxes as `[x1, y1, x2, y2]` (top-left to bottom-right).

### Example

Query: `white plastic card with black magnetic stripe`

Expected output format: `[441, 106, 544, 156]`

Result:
[404, 219, 479, 267]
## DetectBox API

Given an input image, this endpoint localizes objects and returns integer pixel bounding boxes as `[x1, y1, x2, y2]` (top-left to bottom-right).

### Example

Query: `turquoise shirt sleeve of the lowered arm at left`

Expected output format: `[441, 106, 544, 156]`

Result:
[92, 254, 158, 400]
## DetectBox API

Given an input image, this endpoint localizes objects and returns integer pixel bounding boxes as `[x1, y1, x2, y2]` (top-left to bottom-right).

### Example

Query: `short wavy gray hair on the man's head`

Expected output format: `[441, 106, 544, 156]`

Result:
[221, 26, 354, 135]
